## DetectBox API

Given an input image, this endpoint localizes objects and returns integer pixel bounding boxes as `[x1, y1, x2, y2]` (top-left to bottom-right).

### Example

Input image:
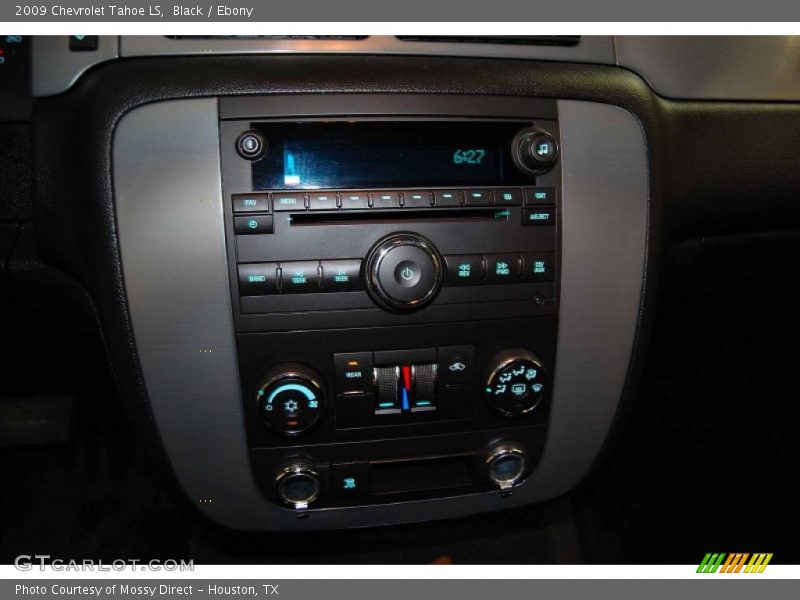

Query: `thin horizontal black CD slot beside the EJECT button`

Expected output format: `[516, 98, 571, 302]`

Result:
[291, 208, 511, 227]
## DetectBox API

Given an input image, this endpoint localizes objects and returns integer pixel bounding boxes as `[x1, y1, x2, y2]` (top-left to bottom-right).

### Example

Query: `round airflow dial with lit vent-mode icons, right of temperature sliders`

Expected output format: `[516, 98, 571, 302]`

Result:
[484, 348, 547, 418]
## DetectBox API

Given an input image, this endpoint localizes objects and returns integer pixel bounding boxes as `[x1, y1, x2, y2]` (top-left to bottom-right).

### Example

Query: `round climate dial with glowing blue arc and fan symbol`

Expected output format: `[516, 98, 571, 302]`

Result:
[256, 364, 325, 436]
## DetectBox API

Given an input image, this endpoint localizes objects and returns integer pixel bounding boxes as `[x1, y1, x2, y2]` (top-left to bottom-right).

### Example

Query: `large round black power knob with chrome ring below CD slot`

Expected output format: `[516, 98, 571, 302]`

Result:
[366, 233, 442, 311]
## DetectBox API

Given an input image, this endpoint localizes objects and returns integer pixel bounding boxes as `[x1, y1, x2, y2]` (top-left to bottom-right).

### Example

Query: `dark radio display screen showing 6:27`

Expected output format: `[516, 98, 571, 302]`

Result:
[253, 121, 532, 190]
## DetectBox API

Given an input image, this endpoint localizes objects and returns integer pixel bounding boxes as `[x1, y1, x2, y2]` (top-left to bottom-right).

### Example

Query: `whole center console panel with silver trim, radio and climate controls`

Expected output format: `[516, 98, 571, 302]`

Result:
[114, 94, 647, 529]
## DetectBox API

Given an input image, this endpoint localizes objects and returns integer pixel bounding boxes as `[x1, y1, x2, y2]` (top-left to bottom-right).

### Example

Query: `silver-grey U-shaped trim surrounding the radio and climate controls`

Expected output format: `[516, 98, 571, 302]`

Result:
[113, 99, 648, 530]
